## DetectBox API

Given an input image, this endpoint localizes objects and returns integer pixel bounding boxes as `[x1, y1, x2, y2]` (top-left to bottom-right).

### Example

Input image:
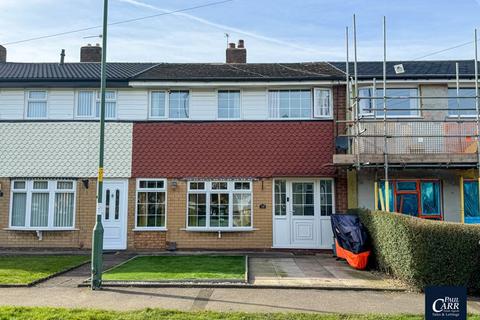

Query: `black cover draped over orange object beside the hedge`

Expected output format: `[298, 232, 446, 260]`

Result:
[332, 214, 370, 253]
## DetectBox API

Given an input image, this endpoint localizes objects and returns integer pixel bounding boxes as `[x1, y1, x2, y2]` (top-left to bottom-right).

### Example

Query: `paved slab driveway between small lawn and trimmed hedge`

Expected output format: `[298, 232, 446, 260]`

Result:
[249, 254, 403, 289]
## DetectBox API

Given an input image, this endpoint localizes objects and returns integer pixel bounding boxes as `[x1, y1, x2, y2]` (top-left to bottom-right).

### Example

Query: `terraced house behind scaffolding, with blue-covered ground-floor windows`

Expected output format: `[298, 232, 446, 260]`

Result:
[334, 60, 480, 223]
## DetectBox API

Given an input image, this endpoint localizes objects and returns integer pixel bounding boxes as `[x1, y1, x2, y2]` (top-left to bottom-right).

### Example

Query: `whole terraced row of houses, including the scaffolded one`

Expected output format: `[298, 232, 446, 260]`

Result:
[0, 41, 480, 251]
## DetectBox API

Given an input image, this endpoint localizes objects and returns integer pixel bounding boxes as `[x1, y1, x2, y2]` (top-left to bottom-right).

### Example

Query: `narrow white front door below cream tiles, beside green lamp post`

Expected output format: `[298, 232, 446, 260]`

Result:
[102, 180, 128, 250]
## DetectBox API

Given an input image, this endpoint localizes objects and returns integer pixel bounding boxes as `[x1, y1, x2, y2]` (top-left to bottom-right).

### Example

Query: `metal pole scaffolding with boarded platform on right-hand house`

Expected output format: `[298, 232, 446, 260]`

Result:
[336, 15, 480, 211]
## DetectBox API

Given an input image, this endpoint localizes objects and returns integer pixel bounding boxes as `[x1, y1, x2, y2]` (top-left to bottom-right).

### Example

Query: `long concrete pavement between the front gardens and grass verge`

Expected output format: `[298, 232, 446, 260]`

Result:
[0, 287, 428, 314]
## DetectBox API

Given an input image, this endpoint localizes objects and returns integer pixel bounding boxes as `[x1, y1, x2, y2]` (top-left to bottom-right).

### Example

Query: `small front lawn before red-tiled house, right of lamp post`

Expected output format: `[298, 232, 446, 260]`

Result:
[103, 256, 245, 281]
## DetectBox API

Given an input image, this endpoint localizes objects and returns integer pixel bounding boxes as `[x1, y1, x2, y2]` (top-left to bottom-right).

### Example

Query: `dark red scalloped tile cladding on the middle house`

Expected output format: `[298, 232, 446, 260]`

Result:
[132, 121, 335, 178]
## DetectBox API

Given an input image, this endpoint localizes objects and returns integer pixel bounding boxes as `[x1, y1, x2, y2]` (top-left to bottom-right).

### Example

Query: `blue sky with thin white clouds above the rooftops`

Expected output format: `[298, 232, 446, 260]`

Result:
[0, 0, 480, 62]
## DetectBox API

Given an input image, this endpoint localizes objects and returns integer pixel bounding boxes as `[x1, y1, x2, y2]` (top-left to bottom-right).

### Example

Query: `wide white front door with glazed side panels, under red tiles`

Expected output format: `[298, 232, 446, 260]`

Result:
[273, 179, 334, 249]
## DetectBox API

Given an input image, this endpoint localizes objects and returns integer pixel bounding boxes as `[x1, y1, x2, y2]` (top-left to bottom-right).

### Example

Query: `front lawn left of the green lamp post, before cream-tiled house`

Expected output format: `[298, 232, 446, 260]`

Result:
[0, 255, 89, 285]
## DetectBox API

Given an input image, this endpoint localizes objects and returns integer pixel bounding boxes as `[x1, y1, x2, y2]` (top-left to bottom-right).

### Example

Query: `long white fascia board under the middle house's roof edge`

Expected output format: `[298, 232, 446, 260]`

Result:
[129, 80, 342, 88]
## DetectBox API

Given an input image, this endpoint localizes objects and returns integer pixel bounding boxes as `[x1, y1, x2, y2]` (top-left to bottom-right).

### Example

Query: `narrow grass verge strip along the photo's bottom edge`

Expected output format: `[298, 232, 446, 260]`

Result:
[0, 307, 442, 320]
